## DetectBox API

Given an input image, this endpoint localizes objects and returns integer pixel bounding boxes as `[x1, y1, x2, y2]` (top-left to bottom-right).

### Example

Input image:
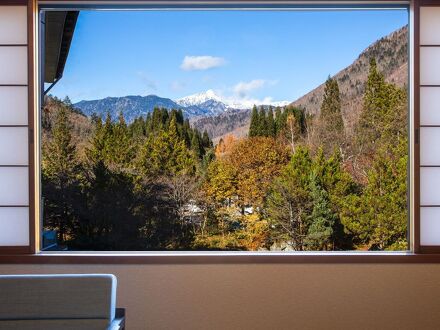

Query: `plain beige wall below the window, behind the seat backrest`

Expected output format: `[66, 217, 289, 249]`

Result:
[0, 264, 440, 330]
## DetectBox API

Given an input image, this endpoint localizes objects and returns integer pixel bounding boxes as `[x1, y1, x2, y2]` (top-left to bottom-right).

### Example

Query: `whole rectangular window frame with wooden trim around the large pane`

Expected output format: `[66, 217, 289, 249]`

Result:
[0, 0, 440, 264]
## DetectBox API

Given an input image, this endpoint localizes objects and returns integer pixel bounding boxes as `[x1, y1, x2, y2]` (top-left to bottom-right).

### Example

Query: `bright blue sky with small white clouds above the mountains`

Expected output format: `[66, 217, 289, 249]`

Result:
[50, 10, 408, 103]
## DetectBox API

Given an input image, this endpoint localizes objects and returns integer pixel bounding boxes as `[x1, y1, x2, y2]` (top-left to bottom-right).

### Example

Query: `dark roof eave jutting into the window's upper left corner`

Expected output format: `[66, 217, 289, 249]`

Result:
[44, 11, 79, 83]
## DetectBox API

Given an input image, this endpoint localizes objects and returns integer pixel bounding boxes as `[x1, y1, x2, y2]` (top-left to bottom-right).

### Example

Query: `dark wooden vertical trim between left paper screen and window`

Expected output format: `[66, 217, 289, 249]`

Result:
[27, 0, 38, 253]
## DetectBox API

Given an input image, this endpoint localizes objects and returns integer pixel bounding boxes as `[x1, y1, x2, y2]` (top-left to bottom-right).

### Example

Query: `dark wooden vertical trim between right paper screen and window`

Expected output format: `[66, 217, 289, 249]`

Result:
[410, 0, 420, 253]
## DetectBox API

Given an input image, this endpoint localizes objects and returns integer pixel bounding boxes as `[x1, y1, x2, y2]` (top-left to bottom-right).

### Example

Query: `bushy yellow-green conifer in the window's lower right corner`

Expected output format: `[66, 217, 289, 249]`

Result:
[342, 139, 408, 250]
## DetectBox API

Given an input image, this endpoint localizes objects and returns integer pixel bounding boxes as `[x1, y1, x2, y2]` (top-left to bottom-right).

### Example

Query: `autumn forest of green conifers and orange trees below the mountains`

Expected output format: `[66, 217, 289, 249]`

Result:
[41, 59, 408, 251]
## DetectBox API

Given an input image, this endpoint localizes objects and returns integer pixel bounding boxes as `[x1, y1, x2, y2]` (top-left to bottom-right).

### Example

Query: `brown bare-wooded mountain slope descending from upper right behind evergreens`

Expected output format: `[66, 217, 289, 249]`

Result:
[192, 26, 408, 141]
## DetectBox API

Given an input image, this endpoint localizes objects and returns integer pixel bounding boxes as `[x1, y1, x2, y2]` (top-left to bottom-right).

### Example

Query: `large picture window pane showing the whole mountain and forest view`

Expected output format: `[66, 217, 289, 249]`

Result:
[40, 7, 409, 252]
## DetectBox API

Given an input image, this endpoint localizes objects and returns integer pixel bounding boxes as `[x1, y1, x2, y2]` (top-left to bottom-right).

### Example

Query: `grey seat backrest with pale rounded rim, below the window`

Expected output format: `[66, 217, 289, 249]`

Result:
[0, 274, 116, 328]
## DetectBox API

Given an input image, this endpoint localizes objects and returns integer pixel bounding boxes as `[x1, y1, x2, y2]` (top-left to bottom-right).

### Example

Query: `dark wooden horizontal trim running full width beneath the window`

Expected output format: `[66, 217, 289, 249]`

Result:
[0, 254, 440, 265]
